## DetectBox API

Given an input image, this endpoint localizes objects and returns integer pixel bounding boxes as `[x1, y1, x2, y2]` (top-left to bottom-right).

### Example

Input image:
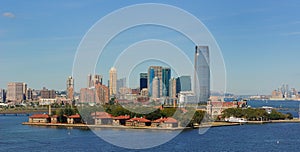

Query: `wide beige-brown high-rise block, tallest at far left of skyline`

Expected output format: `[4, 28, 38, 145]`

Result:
[7, 82, 27, 102]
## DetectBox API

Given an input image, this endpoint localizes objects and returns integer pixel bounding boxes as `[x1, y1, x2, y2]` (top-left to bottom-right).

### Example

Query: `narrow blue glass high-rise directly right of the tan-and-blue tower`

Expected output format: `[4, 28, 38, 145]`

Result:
[161, 67, 171, 97]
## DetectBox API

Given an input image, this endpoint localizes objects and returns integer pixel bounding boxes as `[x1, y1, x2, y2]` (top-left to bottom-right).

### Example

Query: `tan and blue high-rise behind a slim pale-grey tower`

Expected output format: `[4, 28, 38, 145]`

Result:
[147, 66, 162, 96]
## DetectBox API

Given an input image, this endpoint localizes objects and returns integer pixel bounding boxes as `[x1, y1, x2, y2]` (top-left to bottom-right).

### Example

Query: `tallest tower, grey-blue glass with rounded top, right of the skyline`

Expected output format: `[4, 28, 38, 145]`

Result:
[193, 46, 210, 102]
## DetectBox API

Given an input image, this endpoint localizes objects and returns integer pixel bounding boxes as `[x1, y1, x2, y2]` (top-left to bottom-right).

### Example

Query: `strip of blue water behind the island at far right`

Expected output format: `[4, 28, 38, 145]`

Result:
[247, 100, 300, 118]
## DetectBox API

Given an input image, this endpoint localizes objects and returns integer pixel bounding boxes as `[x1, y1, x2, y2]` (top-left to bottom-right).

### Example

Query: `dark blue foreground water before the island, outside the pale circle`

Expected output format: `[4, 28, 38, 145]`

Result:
[0, 116, 300, 152]
